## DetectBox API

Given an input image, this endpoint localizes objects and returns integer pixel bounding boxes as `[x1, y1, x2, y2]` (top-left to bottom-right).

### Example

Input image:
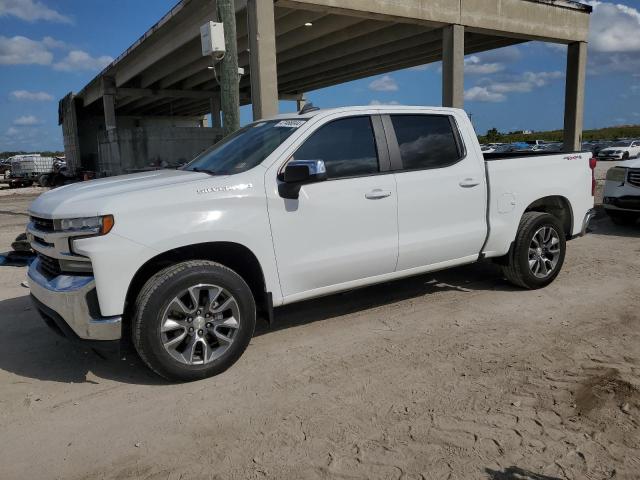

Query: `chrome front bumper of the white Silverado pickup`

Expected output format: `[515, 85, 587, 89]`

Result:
[27, 258, 122, 341]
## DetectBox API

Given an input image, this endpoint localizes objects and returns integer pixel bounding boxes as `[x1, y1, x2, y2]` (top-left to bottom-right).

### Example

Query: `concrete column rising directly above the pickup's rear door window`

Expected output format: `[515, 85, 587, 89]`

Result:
[442, 25, 464, 108]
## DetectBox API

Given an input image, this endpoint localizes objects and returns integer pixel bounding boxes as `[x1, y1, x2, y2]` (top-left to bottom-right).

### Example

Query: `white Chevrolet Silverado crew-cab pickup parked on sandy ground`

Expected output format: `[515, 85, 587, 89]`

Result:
[28, 106, 595, 380]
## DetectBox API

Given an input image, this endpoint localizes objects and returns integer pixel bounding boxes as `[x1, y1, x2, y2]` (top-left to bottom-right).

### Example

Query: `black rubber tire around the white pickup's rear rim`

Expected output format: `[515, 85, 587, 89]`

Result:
[502, 212, 567, 290]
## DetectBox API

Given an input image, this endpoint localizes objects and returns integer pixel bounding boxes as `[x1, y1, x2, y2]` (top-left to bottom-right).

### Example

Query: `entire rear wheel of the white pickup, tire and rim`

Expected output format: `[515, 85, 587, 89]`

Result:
[502, 212, 567, 289]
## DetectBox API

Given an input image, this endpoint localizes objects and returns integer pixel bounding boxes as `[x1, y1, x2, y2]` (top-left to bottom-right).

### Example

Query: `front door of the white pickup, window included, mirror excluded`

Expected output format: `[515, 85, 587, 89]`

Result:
[267, 115, 398, 299]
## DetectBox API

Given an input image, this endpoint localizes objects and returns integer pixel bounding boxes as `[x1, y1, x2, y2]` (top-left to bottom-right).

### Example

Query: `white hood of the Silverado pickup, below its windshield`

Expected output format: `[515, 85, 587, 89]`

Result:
[29, 170, 215, 218]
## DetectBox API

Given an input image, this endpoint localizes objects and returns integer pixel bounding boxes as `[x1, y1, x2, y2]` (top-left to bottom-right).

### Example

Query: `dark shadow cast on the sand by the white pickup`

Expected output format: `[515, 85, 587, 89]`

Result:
[0, 263, 516, 385]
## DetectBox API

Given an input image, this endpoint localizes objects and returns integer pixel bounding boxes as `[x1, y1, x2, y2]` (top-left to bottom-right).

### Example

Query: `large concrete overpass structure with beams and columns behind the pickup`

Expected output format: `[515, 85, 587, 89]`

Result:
[60, 0, 591, 173]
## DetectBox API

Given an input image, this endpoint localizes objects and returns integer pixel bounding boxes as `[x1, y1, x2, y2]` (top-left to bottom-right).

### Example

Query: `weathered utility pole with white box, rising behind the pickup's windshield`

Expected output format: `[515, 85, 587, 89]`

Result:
[218, 0, 240, 136]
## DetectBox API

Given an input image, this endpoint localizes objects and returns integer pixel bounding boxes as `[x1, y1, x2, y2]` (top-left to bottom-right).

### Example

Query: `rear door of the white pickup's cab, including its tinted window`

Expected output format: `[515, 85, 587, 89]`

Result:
[383, 113, 487, 271]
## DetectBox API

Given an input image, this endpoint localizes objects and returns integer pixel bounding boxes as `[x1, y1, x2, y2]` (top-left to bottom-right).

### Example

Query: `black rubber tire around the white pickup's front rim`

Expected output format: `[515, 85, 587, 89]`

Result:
[132, 260, 256, 381]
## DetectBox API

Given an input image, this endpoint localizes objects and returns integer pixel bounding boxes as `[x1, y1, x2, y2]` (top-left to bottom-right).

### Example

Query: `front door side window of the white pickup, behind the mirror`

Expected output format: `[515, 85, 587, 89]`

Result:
[293, 116, 379, 178]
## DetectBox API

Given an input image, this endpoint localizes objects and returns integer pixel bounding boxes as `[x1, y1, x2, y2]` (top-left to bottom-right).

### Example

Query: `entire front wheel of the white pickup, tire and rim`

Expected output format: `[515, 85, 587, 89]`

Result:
[133, 260, 256, 381]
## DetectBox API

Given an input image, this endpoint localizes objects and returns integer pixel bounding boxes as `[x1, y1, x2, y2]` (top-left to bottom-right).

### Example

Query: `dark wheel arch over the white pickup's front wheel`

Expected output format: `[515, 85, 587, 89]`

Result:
[123, 242, 272, 339]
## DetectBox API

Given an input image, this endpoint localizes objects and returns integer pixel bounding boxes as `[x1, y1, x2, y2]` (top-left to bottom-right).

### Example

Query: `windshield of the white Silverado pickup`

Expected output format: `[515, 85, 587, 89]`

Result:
[182, 119, 306, 175]
